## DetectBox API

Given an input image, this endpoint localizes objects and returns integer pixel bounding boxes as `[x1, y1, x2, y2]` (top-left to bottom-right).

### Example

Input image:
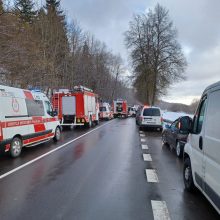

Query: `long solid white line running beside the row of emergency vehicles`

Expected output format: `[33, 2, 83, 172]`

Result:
[0, 121, 113, 179]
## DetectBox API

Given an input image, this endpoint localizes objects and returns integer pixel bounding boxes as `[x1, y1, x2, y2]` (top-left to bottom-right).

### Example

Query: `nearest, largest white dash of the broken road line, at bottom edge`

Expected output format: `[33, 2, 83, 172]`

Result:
[151, 200, 170, 220]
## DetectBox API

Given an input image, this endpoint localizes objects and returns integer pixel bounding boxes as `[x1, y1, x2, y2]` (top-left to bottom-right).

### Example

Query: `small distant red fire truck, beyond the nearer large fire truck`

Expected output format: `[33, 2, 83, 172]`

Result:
[113, 99, 128, 118]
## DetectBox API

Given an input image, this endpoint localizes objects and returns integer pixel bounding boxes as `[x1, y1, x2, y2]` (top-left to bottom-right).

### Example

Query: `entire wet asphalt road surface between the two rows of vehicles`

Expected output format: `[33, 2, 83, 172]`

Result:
[0, 118, 219, 220]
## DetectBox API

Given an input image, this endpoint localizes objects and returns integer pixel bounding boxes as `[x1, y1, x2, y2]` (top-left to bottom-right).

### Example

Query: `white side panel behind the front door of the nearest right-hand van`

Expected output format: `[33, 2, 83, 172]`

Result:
[203, 90, 220, 209]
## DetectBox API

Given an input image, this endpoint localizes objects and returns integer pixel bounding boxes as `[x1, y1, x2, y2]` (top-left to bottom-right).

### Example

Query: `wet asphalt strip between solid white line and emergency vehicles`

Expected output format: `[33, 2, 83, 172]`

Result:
[0, 121, 106, 176]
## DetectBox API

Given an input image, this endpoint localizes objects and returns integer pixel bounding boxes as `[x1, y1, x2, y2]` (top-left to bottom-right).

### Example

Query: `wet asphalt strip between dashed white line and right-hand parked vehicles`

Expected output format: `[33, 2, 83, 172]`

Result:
[145, 132, 219, 220]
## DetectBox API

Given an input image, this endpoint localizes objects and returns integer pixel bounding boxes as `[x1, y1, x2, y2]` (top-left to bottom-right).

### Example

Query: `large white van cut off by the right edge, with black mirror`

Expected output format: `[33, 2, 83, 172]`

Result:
[180, 82, 220, 214]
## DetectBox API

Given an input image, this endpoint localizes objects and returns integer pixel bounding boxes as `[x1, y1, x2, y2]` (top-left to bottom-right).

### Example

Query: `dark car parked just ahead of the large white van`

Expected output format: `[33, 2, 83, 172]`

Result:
[162, 117, 191, 157]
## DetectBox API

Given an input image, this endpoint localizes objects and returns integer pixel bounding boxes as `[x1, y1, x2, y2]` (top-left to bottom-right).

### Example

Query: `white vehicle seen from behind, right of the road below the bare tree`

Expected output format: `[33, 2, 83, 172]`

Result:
[136, 106, 163, 131]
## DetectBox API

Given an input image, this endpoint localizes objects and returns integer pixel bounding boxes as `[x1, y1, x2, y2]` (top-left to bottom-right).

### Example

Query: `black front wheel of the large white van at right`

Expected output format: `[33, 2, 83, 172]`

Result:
[183, 158, 195, 192]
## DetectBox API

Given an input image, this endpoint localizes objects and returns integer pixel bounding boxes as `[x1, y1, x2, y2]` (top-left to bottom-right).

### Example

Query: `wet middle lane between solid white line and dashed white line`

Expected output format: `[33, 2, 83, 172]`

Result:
[0, 119, 153, 220]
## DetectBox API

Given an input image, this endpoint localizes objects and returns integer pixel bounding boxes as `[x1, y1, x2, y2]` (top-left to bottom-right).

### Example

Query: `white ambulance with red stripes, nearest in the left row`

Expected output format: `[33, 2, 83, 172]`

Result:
[0, 85, 61, 157]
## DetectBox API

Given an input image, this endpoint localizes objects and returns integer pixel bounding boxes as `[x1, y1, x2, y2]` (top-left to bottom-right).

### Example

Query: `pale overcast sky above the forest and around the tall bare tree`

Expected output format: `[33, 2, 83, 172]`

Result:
[57, 0, 220, 103]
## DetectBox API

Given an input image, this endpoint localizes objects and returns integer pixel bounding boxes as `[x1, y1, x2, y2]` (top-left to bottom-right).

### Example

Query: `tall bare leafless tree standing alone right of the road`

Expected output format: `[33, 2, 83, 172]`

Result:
[125, 4, 186, 105]
